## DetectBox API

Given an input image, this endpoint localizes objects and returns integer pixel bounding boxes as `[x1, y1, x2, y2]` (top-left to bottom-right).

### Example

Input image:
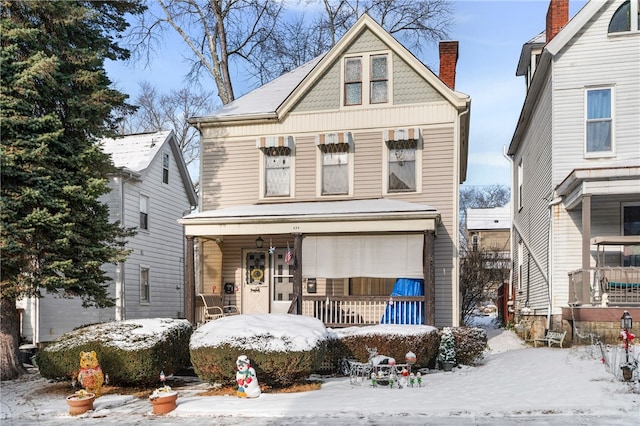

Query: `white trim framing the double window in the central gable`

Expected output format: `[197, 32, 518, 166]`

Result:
[340, 50, 393, 110]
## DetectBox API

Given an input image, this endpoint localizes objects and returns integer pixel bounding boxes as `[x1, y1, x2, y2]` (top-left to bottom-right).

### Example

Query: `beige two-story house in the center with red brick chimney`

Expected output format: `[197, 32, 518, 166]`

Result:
[181, 15, 470, 326]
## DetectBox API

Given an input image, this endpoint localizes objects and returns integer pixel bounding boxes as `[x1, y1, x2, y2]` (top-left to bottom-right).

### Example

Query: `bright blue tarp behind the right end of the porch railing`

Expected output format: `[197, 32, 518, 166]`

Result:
[380, 278, 424, 324]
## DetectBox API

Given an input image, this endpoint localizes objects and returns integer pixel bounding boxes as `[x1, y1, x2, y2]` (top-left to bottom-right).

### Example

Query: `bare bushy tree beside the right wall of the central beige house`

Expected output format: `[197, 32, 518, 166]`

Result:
[460, 247, 511, 324]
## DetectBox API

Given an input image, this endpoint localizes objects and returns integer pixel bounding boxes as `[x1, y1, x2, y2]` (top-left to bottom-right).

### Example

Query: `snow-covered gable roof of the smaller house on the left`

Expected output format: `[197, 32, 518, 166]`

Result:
[100, 130, 197, 206]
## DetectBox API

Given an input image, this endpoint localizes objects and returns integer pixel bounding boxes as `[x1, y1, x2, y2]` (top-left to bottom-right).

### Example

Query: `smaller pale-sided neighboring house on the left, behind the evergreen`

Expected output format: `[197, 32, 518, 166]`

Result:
[18, 131, 197, 344]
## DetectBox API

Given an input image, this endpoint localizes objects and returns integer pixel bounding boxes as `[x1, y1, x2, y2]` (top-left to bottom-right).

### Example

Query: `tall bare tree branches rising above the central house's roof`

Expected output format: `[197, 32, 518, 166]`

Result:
[131, 0, 452, 104]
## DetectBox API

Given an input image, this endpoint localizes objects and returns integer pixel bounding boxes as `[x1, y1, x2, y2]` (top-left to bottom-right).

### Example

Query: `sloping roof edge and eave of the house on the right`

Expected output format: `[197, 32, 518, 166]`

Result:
[507, 0, 609, 155]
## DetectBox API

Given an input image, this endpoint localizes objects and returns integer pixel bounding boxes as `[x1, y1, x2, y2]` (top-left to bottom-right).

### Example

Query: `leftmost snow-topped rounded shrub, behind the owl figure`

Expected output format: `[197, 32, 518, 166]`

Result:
[36, 318, 193, 386]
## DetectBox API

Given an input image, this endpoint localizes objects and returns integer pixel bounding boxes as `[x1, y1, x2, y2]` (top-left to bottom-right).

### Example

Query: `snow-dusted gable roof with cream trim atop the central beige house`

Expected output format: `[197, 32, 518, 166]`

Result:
[189, 14, 470, 124]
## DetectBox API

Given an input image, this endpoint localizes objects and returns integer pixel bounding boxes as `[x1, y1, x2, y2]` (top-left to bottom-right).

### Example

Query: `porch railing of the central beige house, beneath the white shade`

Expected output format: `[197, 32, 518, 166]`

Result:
[302, 296, 424, 327]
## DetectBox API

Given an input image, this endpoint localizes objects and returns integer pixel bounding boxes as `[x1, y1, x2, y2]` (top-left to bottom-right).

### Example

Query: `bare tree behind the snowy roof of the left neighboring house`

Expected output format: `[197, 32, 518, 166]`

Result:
[122, 81, 214, 174]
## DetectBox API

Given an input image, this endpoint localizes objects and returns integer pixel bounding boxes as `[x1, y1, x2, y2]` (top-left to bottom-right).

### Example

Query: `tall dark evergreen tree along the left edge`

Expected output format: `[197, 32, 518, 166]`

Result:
[0, 0, 143, 379]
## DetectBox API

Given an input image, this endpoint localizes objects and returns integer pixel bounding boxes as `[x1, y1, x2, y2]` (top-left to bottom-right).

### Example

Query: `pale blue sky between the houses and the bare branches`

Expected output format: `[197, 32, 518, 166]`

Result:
[106, 0, 586, 185]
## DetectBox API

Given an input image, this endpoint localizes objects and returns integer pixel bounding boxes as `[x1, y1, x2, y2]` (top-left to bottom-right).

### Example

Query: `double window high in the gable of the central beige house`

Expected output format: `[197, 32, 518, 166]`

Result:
[343, 53, 391, 106]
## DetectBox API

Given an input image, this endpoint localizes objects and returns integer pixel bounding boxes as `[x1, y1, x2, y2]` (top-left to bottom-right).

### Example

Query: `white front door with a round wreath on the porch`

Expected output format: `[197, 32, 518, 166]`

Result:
[242, 250, 269, 314]
